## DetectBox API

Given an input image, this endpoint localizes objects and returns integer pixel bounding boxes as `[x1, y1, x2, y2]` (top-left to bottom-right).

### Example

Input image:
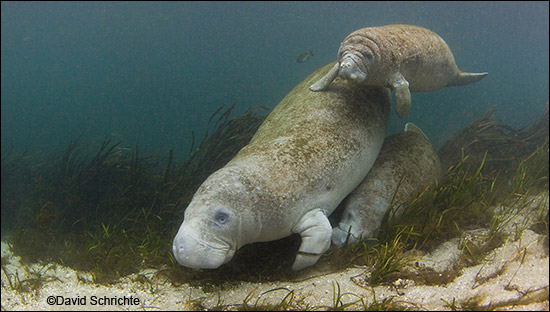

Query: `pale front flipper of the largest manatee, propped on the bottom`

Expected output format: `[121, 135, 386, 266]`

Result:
[292, 209, 332, 271]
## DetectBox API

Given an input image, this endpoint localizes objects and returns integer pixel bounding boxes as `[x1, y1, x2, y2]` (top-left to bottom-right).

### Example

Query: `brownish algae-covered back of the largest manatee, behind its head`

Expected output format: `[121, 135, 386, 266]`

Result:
[228, 63, 390, 201]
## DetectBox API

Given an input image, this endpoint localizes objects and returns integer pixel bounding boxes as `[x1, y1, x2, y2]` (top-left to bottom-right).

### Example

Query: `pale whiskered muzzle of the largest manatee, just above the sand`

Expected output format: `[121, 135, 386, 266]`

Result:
[172, 229, 234, 269]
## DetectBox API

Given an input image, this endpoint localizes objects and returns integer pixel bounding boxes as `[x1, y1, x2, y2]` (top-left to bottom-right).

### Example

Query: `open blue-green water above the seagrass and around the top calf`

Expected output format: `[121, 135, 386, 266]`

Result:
[1, 1, 549, 158]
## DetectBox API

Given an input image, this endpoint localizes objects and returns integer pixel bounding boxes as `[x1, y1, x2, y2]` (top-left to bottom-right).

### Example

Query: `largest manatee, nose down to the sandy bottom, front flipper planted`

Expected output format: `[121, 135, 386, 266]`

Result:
[172, 64, 390, 270]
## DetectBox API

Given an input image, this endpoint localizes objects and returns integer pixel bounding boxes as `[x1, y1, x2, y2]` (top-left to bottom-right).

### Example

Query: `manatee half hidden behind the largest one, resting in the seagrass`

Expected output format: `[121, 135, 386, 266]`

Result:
[332, 123, 442, 245]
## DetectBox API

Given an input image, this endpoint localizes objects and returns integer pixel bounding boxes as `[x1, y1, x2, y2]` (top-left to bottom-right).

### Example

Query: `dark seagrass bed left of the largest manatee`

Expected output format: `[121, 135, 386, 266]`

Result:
[2, 105, 265, 282]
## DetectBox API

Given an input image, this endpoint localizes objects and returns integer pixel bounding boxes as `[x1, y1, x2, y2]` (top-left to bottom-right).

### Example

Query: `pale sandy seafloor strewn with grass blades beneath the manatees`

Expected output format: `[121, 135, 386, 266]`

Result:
[1, 192, 549, 311]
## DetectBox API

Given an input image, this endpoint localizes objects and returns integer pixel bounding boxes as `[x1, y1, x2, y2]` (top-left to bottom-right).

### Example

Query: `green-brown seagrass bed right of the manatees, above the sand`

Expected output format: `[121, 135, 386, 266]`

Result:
[321, 106, 549, 286]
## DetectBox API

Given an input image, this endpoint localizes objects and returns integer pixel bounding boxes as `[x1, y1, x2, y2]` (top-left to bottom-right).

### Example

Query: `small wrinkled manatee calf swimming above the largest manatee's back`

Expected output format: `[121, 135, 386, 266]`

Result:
[311, 25, 487, 117]
